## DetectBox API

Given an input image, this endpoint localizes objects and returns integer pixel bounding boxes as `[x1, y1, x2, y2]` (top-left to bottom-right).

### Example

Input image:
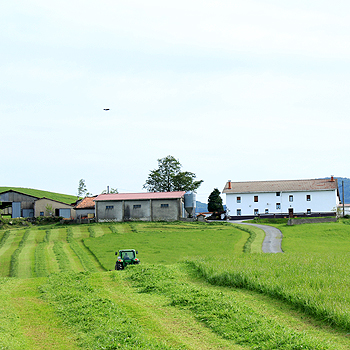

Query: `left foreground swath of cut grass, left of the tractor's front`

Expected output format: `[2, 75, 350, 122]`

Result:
[40, 272, 179, 350]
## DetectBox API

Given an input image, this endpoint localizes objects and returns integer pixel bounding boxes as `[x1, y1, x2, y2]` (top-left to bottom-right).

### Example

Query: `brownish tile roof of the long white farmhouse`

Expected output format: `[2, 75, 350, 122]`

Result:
[222, 179, 338, 193]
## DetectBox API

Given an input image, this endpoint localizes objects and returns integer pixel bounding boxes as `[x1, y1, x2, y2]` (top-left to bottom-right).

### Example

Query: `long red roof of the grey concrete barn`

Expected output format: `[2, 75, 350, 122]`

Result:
[94, 191, 186, 202]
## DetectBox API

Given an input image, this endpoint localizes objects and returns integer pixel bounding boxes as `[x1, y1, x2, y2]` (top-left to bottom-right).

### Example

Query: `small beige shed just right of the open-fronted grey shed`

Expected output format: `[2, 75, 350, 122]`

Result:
[34, 197, 76, 219]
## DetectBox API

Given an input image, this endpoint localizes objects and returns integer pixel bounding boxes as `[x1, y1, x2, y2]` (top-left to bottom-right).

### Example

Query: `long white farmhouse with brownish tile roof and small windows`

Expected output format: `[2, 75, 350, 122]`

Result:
[222, 176, 339, 219]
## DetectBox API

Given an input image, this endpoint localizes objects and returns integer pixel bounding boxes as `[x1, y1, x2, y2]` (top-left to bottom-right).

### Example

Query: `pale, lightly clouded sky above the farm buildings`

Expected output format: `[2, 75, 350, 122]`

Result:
[0, 0, 350, 202]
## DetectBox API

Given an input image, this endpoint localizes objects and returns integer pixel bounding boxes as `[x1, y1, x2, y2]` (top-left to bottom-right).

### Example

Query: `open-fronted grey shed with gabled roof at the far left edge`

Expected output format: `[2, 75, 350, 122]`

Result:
[0, 190, 39, 218]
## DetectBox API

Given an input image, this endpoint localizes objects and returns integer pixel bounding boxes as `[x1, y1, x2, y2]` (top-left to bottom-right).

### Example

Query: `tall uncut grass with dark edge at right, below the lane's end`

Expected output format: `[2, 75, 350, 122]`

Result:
[188, 253, 350, 332]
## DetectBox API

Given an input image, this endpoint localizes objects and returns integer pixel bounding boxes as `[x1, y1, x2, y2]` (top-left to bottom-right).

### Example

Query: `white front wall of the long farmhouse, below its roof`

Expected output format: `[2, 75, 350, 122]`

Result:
[226, 190, 338, 216]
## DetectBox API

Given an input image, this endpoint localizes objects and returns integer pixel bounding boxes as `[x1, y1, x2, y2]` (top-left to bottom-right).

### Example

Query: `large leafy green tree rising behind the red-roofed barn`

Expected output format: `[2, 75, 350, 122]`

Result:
[143, 156, 203, 192]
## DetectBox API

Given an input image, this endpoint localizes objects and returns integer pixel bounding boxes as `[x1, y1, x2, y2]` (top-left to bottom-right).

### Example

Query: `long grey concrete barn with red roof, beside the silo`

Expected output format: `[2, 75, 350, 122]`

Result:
[94, 191, 185, 222]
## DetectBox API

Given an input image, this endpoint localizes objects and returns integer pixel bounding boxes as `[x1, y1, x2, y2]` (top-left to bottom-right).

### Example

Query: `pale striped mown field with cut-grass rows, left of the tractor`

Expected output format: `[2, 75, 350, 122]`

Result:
[0, 226, 106, 278]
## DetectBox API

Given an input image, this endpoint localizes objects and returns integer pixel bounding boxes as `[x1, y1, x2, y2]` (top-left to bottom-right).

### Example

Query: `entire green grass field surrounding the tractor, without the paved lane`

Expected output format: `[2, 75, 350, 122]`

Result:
[0, 220, 350, 350]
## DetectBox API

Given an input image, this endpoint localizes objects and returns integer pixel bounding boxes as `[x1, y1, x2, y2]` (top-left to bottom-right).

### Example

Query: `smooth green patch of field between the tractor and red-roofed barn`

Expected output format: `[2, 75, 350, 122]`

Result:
[84, 222, 252, 270]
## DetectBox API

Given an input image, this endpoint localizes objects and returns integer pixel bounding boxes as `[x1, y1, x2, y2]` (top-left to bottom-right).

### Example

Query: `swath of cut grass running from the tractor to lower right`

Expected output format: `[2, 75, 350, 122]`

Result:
[125, 265, 328, 350]
